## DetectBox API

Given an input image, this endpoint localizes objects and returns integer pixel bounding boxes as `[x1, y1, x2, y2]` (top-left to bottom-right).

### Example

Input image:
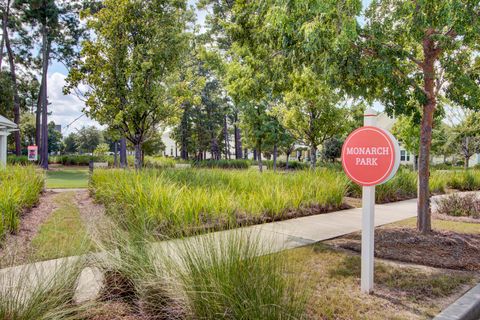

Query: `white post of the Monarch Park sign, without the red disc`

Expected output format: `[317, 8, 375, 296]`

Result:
[361, 108, 377, 293]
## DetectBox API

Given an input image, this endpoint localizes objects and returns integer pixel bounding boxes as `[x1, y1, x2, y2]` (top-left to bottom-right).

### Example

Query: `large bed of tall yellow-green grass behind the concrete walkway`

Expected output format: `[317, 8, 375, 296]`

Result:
[90, 169, 346, 233]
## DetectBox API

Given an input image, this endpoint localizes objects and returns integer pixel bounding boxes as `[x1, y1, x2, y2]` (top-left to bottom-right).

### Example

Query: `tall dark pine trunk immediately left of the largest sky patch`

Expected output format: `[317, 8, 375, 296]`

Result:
[40, 24, 49, 170]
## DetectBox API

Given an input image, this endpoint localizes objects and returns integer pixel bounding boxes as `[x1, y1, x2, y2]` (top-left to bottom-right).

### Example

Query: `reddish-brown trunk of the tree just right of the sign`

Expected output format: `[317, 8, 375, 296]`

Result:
[417, 37, 437, 234]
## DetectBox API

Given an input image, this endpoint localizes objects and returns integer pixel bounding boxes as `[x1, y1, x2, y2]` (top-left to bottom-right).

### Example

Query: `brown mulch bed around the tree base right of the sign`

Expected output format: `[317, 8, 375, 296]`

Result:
[330, 227, 480, 271]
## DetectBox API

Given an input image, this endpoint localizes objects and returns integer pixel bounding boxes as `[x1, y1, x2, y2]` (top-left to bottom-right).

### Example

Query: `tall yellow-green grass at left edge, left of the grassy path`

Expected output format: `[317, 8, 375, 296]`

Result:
[0, 166, 44, 236]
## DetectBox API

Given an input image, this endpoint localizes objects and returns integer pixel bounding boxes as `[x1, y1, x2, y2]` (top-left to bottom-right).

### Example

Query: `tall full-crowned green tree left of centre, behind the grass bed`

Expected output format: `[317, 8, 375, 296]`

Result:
[66, 0, 191, 169]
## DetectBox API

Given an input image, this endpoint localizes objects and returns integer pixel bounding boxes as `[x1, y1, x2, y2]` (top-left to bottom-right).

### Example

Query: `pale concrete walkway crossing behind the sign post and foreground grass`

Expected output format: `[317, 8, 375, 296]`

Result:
[0, 194, 458, 301]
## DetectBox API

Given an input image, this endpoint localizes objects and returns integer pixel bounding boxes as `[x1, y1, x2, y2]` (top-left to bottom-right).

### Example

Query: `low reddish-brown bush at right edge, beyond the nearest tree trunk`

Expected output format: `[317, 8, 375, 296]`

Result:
[436, 193, 480, 219]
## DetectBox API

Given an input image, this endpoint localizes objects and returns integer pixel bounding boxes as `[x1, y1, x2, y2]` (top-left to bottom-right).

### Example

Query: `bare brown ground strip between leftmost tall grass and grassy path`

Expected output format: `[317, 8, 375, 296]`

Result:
[0, 191, 57, 268]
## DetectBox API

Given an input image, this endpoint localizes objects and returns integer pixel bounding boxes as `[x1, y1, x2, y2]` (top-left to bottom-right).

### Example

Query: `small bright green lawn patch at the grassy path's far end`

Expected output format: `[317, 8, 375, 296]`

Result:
[47, 169, 88, 189]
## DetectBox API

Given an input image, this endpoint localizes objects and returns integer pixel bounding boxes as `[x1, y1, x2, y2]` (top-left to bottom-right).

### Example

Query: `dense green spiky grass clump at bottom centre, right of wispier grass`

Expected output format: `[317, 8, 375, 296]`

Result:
[172, 232, 307, 320]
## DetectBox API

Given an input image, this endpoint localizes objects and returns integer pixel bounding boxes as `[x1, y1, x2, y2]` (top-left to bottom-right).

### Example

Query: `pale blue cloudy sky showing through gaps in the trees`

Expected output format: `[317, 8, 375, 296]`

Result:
[48, 0, 372, 136]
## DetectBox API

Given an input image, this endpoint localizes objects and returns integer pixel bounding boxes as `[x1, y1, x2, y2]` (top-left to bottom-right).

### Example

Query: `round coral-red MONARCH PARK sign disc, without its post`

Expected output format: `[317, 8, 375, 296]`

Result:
[342, 126, 400, 186]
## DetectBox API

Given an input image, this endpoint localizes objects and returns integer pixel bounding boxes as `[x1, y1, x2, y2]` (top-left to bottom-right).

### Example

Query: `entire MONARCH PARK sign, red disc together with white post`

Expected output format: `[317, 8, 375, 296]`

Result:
[342, 109, 400, 293]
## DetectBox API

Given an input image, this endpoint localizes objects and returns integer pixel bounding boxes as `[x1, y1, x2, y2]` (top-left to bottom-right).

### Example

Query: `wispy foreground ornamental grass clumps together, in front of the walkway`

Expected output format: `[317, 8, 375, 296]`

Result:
[97, 222, 308, 320]
